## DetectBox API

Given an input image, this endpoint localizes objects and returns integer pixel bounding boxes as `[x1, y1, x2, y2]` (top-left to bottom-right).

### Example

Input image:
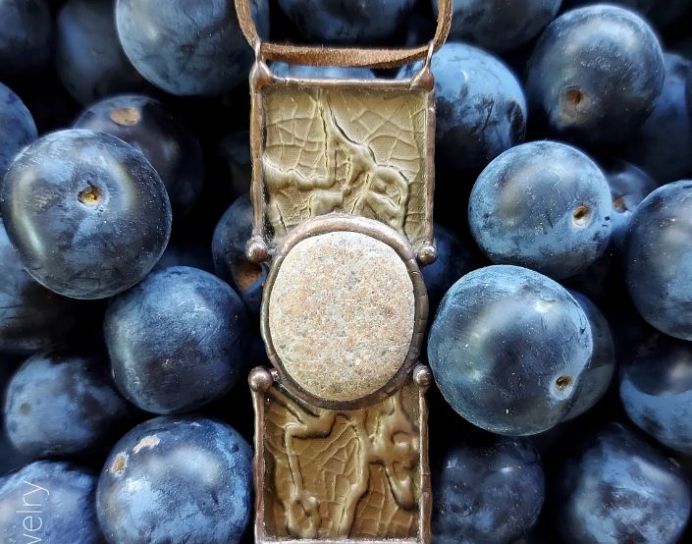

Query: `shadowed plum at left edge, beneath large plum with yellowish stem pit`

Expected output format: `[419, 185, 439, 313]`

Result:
[0, 219, 77, 354]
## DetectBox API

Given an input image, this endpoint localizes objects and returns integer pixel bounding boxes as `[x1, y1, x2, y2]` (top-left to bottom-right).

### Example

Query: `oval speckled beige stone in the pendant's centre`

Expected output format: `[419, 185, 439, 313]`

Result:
[268, 232, 415, 402]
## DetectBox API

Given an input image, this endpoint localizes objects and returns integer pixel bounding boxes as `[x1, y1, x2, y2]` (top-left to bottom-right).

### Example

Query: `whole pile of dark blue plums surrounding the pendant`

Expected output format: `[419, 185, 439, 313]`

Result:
[0, 0, 692, 544]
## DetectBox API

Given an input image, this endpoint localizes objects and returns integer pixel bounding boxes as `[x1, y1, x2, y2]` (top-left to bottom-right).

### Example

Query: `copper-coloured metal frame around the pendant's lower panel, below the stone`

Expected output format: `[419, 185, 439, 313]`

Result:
[248, 365, 432, 544]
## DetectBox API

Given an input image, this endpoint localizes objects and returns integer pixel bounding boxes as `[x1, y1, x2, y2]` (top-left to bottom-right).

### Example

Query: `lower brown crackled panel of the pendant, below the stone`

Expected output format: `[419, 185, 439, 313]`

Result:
[260, 382, 425, 541]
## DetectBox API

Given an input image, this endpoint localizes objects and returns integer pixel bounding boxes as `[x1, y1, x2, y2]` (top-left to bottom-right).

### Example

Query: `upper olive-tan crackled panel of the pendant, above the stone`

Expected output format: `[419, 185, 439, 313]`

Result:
[261, 81, 432, 249]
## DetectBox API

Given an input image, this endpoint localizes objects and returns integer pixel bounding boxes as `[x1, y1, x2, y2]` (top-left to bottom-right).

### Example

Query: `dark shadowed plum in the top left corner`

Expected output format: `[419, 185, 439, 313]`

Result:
[0, 0, 53, 81]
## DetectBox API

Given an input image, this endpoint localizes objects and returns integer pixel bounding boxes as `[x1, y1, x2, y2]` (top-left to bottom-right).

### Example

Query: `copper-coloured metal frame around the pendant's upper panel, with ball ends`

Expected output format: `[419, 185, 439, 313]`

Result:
[247, 61, 437, 265]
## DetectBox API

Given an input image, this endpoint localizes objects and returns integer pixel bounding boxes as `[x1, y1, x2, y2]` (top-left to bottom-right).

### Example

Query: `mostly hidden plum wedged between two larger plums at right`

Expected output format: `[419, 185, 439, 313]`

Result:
[605, 161, 657, 251]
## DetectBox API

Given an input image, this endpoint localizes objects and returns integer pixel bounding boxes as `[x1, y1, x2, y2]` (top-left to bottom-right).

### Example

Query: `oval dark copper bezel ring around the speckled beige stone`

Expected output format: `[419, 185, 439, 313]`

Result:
[260, 213, 428, 410]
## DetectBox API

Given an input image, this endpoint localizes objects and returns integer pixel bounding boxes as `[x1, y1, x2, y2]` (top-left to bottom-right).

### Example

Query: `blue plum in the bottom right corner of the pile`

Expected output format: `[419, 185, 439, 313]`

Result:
[555, 424, 690, 544]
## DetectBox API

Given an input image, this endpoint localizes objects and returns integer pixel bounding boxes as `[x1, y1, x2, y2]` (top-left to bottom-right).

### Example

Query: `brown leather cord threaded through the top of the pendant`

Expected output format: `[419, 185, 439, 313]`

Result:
[235, 0, 452, 68]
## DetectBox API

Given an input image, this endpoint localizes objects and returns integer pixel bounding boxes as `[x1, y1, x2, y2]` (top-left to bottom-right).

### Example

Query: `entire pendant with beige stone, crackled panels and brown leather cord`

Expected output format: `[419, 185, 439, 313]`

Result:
[236, 0, 451, 544]
